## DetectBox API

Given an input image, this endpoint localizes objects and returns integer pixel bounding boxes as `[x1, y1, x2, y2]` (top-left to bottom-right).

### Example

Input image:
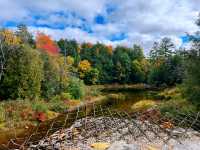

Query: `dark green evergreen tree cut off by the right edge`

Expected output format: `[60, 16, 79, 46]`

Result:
[183, 14, 200, 105]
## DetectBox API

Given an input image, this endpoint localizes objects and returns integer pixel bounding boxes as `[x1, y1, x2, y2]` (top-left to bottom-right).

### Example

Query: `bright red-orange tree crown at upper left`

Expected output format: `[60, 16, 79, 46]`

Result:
[36, 33, 59, 55]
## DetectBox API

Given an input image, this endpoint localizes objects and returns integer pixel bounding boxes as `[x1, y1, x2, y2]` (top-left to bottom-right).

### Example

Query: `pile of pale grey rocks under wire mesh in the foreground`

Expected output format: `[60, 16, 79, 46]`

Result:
[29, 117, 200, 150]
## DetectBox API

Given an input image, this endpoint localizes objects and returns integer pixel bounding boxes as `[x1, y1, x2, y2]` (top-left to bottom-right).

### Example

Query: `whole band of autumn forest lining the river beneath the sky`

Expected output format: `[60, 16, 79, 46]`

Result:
[0, 13, 200, 132]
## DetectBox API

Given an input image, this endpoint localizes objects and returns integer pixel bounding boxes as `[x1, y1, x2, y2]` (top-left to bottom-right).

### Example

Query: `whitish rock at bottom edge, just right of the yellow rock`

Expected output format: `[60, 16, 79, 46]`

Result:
[108, 141, 140, 150]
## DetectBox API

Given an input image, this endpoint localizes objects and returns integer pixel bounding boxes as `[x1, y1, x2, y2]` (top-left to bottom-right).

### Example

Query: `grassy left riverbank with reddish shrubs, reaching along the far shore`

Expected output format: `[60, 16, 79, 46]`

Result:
[0, 84, 154, 131]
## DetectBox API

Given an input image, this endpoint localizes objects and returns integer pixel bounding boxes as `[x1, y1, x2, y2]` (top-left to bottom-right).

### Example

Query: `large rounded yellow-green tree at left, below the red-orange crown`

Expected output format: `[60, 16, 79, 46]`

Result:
[0, 46, 43, 99]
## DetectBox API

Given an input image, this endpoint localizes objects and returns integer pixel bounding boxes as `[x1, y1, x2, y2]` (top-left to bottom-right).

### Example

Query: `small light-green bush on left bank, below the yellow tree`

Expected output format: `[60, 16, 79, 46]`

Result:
[67, 77, 85, 99]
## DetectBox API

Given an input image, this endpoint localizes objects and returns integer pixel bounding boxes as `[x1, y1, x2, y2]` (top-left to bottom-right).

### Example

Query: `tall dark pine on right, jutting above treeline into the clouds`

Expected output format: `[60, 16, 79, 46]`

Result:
[148, 38, 184, 86]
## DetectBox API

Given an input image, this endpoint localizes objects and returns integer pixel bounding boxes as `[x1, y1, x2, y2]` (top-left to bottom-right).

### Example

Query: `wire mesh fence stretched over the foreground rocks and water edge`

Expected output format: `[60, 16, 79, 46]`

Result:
[1, 104, 200, 149]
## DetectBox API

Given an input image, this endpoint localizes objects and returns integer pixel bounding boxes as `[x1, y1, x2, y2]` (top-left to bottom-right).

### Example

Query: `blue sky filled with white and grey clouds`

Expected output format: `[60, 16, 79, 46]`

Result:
[0, 0, 200, 53]
